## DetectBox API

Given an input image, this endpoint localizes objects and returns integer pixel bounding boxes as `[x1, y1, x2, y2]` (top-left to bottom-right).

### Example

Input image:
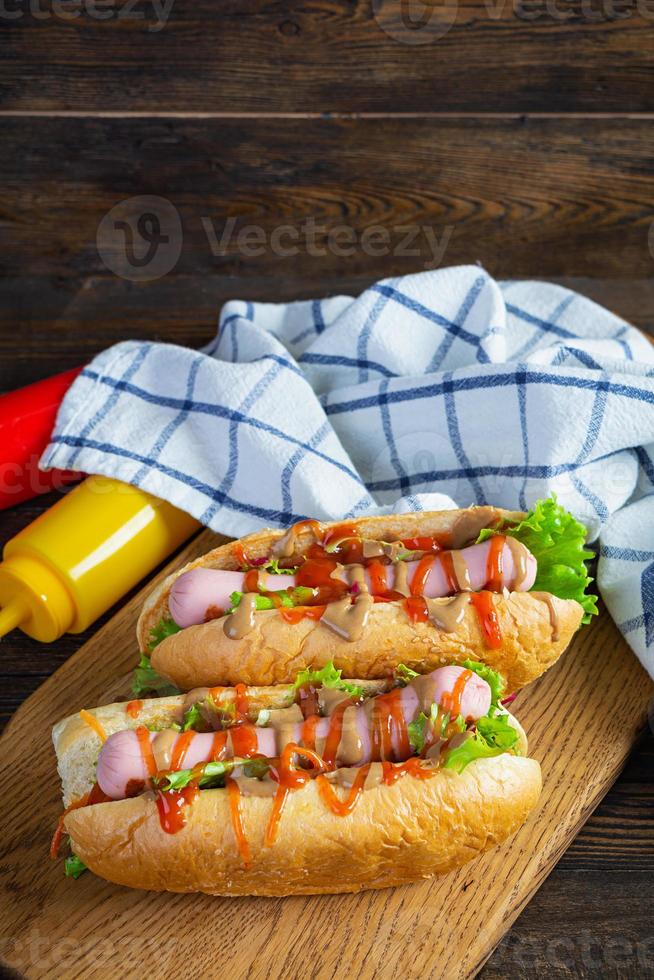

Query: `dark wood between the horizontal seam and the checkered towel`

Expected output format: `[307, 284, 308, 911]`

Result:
[0, 118, 654, 387]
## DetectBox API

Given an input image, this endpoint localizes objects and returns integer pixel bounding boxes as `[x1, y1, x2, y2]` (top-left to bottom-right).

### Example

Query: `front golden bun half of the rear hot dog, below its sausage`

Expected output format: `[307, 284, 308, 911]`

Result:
[152, 592, 583, 691]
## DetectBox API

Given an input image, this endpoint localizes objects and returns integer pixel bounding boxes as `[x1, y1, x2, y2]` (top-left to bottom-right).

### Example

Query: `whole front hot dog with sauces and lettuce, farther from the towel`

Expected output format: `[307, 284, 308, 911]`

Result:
[53, 661, 541, 895]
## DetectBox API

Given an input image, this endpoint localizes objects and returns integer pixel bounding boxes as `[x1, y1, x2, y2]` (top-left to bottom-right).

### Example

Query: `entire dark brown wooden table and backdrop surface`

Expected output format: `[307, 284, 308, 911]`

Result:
[0, 0, 654, 978]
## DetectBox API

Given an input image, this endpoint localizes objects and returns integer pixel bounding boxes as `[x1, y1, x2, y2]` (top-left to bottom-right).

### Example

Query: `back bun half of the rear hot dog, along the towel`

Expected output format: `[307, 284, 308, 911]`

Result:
[136, 507, 525, 652]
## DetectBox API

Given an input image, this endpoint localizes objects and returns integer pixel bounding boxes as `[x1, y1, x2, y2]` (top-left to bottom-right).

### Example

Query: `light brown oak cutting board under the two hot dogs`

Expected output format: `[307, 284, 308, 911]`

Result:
[0, 532, 654, 980]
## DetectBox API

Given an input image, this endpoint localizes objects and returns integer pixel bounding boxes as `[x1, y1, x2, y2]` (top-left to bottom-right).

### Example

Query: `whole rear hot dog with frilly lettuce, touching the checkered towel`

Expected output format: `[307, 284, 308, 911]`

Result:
[138, 499, 594, 690]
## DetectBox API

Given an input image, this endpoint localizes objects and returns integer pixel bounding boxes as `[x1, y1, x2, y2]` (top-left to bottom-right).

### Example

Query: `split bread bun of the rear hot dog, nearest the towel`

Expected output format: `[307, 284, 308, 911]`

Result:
[137, 507, 583, 691]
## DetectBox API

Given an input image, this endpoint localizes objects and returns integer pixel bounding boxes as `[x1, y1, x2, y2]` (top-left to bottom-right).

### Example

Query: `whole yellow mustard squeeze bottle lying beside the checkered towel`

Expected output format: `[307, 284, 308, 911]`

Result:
[0, 476, 200, 643]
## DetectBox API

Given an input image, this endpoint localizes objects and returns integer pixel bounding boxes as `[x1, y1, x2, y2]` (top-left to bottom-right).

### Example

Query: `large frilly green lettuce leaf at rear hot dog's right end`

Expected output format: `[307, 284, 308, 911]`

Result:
[477, 494, 597, 623]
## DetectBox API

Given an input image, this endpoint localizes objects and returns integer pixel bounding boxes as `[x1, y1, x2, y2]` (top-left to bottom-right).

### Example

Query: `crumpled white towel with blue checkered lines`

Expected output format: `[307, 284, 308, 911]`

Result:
[42, 266, 654, 675]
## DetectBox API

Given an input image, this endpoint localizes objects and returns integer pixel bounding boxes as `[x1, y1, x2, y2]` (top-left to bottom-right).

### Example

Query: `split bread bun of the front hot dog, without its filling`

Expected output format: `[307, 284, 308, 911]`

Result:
[53, 681, 541, 895]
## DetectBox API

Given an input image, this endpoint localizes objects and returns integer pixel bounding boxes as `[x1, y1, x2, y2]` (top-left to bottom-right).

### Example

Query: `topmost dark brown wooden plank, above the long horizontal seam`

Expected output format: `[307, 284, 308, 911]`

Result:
[0, 0, 654, 113]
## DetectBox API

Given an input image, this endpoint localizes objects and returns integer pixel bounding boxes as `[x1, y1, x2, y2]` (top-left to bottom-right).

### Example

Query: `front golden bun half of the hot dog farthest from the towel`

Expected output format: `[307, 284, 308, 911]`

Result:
[65, 755, 541, 895]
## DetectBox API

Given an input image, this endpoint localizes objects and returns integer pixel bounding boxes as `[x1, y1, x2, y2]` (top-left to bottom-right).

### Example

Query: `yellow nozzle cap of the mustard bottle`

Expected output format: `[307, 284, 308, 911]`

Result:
[0, 555, 75, 643]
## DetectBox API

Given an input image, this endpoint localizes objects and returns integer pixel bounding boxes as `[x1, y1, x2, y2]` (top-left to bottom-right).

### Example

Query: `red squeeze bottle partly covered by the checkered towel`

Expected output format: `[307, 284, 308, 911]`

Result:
[0, 367, 82, 510]
